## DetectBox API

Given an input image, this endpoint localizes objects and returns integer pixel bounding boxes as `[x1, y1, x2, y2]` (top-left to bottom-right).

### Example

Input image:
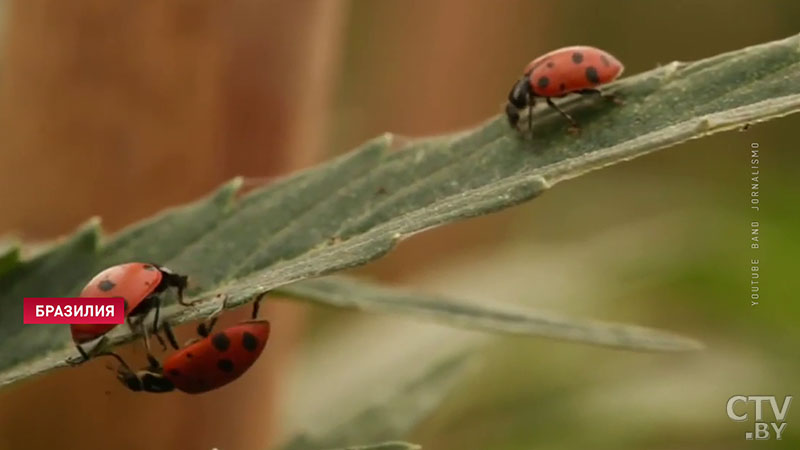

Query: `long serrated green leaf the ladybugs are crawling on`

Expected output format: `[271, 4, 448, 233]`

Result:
[0, 36, 800, 385]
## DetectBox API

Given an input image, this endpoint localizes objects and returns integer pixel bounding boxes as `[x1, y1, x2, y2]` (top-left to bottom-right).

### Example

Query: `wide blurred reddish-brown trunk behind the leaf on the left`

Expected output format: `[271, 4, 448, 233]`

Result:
[0, 0, 346, 450]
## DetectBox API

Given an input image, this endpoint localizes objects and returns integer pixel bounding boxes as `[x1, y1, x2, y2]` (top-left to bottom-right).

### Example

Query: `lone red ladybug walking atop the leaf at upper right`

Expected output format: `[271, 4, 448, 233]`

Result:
[506, 46, 624, 130]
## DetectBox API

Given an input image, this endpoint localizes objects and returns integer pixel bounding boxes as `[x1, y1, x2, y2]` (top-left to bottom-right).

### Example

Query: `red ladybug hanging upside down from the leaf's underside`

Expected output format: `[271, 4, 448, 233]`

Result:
[105, 298, 270, 394]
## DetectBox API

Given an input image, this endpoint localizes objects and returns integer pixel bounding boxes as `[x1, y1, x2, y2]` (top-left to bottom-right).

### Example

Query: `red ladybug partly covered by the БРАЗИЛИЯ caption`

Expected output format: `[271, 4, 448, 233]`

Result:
[70, 263, 190, 361]
